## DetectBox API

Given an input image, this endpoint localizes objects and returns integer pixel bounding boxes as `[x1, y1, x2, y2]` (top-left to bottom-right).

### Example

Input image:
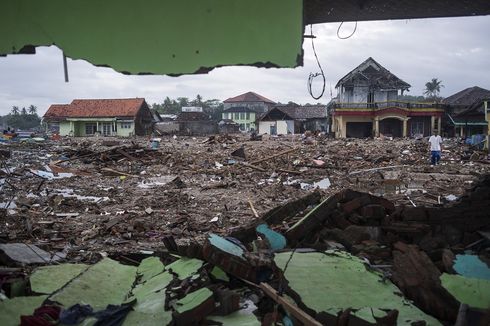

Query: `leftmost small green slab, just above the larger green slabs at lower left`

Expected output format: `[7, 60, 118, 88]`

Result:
[29, 264, 88, 294]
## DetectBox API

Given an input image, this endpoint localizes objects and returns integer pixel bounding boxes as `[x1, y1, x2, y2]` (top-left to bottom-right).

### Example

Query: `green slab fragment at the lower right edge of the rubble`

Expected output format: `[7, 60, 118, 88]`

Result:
[440, 273, 490, 309]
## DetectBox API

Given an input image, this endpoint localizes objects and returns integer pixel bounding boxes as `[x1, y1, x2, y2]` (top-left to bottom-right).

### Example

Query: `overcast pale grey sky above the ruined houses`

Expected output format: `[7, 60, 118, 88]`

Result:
[0, 16, 490, 115]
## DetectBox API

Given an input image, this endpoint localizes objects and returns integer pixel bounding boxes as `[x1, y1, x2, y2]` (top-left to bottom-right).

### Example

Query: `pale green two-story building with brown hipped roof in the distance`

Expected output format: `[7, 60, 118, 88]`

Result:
[222, 92, 275, 131]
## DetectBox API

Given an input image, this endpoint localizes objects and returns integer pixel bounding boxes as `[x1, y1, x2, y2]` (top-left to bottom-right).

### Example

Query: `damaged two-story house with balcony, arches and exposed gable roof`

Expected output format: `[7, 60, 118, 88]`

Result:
[332, 57, 444, 138]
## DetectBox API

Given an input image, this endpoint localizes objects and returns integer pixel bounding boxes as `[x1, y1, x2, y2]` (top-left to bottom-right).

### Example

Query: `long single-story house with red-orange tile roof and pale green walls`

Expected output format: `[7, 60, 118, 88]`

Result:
[43, 98, 154, 137]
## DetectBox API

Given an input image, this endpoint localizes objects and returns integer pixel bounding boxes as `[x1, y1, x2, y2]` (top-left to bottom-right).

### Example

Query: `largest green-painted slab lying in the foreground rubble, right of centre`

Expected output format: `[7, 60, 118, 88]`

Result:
[274, 252, 440, 325]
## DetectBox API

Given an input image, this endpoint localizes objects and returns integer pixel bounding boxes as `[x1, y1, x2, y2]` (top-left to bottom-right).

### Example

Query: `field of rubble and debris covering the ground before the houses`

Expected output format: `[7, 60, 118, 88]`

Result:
[0, 135, 490, 325]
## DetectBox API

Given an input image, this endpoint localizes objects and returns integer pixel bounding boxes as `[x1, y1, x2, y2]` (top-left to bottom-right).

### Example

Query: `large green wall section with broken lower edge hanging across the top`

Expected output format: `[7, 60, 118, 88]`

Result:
[0, 0, 303, 74]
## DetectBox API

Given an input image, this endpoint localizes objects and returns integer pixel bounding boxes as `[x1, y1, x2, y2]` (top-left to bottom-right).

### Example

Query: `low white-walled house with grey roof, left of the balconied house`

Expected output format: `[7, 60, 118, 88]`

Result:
[259, 105, 328, 135]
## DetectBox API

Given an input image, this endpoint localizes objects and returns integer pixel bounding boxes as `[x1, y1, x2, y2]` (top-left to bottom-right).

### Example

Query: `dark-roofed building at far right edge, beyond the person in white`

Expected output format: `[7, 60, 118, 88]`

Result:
[442, 86, 490, 137]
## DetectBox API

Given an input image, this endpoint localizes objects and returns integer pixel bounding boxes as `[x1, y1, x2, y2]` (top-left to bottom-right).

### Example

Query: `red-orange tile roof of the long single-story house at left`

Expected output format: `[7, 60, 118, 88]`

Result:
[44, 98, 145, 119]
